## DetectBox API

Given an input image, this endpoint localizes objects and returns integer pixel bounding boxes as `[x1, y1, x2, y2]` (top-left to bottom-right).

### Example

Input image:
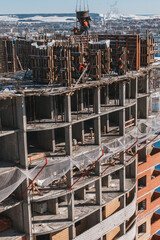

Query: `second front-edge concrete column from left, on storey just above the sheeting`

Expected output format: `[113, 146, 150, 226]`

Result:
[65, 125, 72, 156]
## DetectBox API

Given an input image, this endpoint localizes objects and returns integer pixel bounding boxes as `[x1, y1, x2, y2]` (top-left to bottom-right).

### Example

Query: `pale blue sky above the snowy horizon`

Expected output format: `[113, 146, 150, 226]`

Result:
[0, 0, 160, 14]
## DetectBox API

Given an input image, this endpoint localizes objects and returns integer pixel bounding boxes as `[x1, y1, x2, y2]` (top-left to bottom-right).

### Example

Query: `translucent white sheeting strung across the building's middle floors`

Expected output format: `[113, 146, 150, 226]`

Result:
[0, 115, 160, 202]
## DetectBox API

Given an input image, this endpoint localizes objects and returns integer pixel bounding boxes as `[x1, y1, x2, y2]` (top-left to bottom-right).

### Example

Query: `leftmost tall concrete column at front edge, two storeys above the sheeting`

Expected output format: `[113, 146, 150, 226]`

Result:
[16, 97, 28, 168]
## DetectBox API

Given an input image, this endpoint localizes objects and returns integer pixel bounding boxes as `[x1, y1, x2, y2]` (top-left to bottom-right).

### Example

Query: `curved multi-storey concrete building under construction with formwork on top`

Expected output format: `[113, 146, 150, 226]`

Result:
[0, 35, 160, 240]
